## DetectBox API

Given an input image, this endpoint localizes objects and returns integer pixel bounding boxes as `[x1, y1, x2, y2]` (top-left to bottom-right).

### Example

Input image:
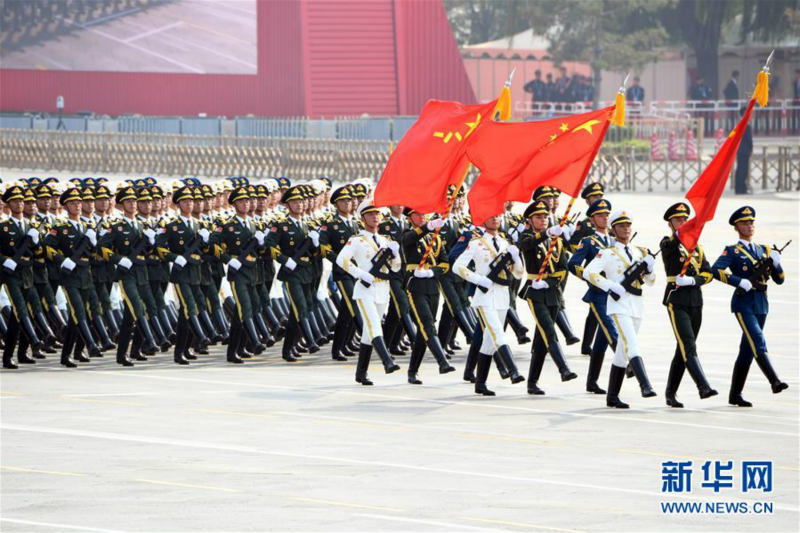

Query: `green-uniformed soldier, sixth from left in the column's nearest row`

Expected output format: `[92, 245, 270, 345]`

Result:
[268, 185, 319, 362]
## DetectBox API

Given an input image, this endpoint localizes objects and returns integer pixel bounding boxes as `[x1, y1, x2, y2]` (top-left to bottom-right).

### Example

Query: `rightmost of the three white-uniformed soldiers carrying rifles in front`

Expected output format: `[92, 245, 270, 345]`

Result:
[583, 211, 656, 409]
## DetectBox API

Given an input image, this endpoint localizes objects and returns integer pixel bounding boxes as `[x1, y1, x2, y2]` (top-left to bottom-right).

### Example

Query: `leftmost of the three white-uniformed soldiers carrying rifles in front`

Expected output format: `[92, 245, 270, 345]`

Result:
[336, 198, 401, 385]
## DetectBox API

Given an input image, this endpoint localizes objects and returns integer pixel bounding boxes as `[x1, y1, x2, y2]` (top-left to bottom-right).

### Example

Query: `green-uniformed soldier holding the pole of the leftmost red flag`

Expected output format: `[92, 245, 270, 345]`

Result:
[400, 208, 455, 385]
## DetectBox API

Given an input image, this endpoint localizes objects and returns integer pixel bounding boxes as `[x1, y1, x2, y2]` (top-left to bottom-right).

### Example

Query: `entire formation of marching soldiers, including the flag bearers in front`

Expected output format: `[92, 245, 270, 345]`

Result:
[0, 178, 787, 408]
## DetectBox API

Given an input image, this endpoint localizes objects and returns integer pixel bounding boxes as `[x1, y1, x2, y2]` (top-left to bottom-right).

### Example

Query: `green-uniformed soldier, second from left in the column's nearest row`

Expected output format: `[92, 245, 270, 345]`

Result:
[45, 187, 108, 368]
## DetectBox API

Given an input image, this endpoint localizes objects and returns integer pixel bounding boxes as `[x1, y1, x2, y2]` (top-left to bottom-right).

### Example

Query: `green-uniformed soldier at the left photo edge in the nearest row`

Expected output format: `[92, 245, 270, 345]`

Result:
[0, 185, 42, 369]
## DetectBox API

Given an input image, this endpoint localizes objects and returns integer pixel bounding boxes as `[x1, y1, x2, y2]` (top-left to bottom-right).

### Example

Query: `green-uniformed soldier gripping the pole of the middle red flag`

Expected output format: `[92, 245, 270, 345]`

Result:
[518, 200, 578, 394]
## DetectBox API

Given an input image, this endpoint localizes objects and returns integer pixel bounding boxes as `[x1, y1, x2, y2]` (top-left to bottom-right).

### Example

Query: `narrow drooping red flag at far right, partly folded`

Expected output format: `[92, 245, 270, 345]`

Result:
[678, 99, 755, 250]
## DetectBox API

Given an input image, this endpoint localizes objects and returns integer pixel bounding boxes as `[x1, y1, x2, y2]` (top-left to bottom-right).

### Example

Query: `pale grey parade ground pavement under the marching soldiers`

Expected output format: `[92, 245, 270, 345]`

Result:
[0, 189, 800, 532]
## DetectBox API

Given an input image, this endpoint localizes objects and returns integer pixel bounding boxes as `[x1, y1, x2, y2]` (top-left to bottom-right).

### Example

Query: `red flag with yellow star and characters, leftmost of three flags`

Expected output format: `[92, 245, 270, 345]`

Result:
[375, 100, 497, 213]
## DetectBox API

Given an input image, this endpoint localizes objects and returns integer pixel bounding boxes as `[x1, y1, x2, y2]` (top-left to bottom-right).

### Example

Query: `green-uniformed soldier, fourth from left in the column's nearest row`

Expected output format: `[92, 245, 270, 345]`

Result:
[158, 186, 210, 365]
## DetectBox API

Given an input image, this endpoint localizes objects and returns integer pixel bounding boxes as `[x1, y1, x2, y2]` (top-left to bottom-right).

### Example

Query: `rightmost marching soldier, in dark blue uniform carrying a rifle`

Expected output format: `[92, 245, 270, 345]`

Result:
[711, 206, 789, 407]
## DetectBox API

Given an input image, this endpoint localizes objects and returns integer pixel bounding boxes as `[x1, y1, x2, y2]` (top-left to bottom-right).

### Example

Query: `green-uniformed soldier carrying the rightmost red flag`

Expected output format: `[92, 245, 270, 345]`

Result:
[660, 202, 717, 408]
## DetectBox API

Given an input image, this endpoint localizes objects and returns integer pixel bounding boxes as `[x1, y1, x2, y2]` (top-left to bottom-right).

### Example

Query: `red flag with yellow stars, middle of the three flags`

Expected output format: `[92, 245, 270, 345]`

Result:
[467, 106, 614, 225]
